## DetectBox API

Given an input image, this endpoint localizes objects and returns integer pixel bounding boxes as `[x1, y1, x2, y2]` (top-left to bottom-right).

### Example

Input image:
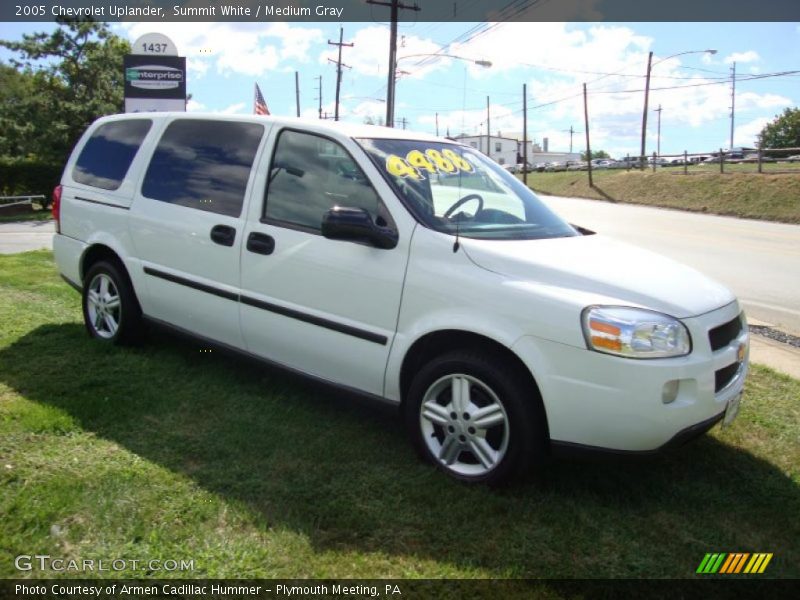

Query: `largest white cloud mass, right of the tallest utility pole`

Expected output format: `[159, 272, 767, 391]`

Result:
[400, 23, 791, 156]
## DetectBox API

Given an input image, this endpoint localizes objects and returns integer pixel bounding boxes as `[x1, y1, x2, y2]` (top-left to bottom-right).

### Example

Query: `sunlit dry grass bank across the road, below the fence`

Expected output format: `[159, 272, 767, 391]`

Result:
[528, 164, 800, 223]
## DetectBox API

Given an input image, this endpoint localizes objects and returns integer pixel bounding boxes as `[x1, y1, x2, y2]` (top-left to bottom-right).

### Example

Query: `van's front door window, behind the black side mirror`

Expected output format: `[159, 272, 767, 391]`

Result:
[263, 129, 386, 233]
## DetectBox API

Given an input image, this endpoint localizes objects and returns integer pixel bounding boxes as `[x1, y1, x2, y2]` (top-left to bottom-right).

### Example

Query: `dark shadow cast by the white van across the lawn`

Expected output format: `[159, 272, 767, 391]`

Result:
[0, 324, 800, 578]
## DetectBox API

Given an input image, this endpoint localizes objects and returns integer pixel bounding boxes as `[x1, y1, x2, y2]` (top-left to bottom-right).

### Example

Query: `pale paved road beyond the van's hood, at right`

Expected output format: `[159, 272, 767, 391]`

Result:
[542, 196, 800, 335]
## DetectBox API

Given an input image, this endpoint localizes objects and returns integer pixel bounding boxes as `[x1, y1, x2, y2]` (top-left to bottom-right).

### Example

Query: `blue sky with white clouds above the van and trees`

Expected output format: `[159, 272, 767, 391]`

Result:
[0, 22, 800, 156]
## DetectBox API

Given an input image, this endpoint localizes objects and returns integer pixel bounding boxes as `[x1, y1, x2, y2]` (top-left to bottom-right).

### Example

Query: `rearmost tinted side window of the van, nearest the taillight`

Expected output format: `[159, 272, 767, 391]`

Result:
[72, 119, 153, 190]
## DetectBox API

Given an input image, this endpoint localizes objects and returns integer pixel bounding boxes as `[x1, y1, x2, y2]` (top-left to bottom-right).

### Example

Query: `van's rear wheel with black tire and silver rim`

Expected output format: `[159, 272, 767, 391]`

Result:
[82, 261, 142, 345]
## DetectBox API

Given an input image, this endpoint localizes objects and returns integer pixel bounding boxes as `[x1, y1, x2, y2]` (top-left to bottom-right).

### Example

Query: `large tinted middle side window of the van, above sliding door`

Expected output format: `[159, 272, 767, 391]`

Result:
[142, 119, 264, 217]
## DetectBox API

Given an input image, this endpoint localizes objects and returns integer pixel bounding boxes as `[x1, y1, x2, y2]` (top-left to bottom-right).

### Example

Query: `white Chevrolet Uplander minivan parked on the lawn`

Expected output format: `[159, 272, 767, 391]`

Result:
[54, 113, 748, 482]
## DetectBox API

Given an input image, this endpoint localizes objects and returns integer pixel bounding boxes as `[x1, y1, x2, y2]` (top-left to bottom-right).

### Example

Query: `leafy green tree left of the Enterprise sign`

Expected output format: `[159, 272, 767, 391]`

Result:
[0, 19, 130, 162]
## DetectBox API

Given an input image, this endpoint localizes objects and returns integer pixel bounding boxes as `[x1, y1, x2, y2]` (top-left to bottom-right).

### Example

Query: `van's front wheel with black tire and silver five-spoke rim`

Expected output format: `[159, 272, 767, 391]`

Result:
[405, 350, 547, 486]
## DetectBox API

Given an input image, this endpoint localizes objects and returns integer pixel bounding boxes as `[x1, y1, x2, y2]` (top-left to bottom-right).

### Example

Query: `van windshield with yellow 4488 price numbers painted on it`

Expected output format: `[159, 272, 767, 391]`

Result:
[358, 139, 579, 240]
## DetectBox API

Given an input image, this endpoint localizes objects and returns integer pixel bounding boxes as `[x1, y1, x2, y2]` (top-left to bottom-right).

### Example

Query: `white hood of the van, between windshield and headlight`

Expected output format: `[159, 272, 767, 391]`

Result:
[461, 235, 735, 318]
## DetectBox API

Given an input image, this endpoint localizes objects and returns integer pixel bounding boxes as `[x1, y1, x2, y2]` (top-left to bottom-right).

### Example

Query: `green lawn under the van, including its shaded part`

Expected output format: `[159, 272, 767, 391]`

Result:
[0, 251, 800, 578]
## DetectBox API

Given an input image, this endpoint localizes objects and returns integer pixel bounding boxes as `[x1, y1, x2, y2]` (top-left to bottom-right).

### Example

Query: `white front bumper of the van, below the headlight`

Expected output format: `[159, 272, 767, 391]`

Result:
[514, 302, 749, 453]
